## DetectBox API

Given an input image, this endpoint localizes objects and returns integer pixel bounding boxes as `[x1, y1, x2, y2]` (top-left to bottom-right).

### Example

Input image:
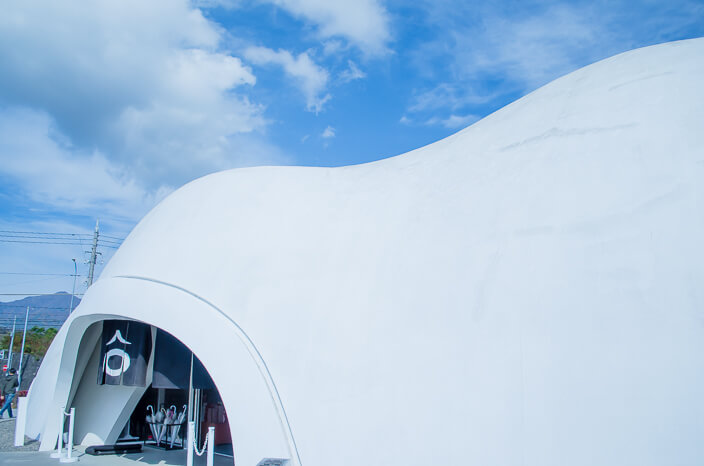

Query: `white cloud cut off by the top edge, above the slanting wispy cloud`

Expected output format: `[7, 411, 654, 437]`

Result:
[260, 0, 390, 55]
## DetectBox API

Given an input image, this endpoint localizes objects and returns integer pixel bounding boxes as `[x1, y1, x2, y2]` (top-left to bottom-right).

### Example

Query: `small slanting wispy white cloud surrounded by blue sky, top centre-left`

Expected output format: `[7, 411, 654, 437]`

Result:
[244, 47, 330, 113]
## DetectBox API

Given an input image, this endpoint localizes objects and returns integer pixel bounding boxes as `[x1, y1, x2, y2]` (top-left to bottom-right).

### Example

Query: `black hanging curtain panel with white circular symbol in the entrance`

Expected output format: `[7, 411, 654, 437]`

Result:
[98, 320, 152, 387]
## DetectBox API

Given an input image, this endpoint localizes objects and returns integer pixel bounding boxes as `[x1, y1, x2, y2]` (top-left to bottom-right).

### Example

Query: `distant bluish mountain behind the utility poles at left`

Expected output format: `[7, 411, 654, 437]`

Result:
[0, 291, 81, 333]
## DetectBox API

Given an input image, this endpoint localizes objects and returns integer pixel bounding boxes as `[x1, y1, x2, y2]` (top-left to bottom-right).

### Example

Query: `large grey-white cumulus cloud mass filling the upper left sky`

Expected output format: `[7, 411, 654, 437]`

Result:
[0, 0, 276, 193]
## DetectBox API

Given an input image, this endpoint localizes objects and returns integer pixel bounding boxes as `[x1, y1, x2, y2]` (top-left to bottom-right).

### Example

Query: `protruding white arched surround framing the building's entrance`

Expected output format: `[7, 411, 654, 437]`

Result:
[28, 277, 300, 466]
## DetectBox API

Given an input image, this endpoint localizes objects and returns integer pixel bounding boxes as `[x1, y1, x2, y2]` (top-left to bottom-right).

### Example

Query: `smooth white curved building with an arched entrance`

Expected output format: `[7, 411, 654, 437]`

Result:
[27, 39, 704, 466]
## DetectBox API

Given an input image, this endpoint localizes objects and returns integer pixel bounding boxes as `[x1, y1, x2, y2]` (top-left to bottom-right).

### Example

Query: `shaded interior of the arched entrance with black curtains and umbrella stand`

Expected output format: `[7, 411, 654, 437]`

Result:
[70, 319, 233, 456]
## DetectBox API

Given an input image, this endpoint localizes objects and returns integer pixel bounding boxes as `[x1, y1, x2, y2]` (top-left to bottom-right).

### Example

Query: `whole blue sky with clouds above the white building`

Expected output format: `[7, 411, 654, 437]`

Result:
[0, 0, 704, 300]
